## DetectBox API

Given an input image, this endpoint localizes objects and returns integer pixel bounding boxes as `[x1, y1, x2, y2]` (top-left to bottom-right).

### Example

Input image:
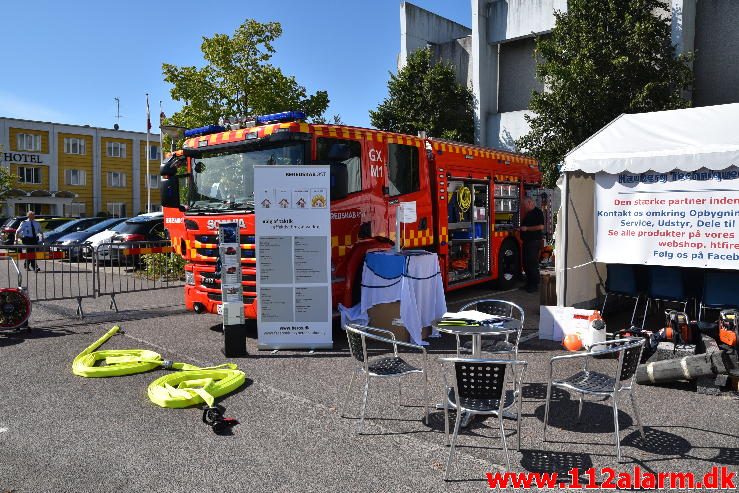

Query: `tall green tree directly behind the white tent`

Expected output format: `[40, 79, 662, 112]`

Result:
[516, 0, 693, 187]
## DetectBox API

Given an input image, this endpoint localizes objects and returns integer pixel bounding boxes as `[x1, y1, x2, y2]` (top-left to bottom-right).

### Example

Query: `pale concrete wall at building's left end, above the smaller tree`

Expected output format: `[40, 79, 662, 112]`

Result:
[398, 2, 472, 68]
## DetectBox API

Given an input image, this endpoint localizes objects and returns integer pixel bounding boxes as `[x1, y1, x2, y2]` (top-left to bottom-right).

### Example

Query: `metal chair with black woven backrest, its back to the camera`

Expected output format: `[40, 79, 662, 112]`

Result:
[441, 358, 528, 480]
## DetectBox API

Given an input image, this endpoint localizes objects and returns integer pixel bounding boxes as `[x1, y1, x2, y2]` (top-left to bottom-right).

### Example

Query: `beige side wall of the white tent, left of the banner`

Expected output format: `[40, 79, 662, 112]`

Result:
[555, 172, 606, 308]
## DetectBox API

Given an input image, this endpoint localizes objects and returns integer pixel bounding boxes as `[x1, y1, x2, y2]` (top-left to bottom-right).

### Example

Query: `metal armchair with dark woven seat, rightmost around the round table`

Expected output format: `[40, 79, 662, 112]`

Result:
[542, 337, 644, 462]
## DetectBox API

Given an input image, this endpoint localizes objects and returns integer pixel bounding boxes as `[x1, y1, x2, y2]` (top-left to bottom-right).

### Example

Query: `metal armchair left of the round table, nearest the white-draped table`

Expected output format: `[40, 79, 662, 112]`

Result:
[341, 323, 429, 433]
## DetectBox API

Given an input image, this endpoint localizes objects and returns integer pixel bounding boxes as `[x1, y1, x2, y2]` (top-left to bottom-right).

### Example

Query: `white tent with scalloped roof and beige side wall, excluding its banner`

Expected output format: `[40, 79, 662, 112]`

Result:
[556, 104, 739, 306]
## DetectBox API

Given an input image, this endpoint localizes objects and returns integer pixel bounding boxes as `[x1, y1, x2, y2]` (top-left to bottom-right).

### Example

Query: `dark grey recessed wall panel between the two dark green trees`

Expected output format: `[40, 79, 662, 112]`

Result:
[498, 38, 544, 113]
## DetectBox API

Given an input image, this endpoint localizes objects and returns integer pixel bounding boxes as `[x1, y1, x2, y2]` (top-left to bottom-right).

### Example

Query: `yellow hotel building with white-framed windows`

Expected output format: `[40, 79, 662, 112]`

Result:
[0, 117, 161, 217]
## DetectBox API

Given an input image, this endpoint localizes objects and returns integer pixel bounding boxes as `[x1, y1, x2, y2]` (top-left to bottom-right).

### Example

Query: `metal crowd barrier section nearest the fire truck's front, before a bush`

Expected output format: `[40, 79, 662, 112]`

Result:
[94, 241, 185, 311]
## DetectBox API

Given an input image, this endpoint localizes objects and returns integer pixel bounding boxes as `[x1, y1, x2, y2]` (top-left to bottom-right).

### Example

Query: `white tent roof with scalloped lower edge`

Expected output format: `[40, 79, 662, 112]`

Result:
[562, 103, 739, 174]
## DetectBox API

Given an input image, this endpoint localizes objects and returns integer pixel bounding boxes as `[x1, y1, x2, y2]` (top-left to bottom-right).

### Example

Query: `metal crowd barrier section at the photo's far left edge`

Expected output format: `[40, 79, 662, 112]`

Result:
[0, 245, 96, 317]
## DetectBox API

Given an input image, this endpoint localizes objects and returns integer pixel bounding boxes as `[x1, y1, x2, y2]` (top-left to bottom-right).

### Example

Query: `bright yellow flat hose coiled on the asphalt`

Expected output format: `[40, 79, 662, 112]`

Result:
[72, 326, 246, 408]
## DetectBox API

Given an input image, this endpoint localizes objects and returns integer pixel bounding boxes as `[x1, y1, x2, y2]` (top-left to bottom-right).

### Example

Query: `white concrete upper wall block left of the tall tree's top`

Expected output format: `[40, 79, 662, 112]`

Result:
[492, 0, 567, 43]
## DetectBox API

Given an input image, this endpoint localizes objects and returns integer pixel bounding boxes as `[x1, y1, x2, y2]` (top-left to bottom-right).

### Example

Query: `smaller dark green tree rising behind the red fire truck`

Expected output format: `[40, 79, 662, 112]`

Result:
[370, 49, 475, 142]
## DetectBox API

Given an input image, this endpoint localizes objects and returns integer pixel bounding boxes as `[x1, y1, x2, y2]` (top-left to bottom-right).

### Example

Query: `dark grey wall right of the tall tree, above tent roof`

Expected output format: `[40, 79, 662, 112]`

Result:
[693, 0, 739, 106]
